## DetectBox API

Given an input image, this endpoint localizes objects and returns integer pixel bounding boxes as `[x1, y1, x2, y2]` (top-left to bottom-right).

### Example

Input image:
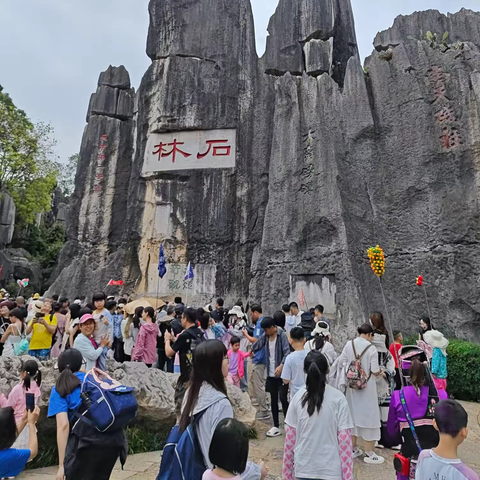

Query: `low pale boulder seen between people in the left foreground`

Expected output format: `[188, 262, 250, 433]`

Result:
[0, 356, 256, 428]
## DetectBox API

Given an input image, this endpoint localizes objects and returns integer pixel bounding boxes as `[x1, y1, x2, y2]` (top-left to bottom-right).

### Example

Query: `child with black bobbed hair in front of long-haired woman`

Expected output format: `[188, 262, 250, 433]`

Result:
[202, 418, 268, 480]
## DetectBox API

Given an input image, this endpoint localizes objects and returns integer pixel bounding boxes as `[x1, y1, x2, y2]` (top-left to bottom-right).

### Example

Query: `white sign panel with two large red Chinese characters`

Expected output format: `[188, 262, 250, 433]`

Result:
[142, 129, 236, 173]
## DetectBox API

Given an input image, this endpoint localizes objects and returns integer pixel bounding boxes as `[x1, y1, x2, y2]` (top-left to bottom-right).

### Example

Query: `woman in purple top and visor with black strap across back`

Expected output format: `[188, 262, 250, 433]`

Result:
[387, 347, 448, 480]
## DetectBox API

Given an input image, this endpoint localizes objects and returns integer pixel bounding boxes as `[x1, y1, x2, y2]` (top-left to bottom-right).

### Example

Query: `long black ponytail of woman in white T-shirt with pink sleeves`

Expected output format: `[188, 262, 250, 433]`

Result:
[302, 350, 328, 417]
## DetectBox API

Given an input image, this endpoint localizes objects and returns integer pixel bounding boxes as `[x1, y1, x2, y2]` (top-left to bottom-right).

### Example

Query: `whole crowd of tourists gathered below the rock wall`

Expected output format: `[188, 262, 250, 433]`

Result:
[0, 293, 479, 480]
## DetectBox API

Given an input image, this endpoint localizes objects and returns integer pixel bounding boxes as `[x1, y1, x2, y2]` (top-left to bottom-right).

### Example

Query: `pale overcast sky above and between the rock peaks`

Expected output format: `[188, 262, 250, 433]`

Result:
[0, 0, 480, 161]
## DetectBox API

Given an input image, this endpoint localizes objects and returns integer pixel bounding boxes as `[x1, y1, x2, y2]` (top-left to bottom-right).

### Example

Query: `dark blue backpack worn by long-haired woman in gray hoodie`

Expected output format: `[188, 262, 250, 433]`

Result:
[157, 408, 212, 480]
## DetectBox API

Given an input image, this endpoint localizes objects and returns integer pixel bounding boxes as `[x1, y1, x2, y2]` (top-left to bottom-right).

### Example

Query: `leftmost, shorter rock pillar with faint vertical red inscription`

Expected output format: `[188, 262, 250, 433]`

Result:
[50, 66, 135, 296]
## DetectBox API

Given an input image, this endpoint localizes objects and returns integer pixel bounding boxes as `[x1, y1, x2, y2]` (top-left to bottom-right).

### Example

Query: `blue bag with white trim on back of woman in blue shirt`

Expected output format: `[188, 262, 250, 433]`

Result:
[75, 368, 138, 433]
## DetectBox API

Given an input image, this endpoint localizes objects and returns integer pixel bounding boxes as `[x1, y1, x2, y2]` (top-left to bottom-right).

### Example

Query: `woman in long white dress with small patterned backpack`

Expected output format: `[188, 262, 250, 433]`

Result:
[338, 323, 385, 465]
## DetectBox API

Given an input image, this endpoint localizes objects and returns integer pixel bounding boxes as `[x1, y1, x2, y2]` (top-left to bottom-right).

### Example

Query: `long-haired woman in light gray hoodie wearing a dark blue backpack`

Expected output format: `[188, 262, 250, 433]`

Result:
[161, 340, 267, 480]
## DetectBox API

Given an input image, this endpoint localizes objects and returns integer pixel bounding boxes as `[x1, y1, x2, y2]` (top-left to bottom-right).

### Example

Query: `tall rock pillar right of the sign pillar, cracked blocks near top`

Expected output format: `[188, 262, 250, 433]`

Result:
[250, 0, 366, 340]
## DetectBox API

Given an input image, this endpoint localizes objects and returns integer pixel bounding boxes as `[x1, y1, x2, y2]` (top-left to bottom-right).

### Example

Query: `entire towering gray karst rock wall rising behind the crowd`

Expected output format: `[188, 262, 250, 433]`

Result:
[50, 0, 480, 340]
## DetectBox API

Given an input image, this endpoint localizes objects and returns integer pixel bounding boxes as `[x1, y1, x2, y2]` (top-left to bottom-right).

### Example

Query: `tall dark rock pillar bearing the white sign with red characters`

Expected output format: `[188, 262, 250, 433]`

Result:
[124, 0, 270, 305]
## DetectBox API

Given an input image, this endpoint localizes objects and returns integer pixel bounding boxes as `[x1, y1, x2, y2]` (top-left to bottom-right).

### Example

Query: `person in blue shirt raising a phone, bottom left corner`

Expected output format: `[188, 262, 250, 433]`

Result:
[0, 407, 40, 478]
